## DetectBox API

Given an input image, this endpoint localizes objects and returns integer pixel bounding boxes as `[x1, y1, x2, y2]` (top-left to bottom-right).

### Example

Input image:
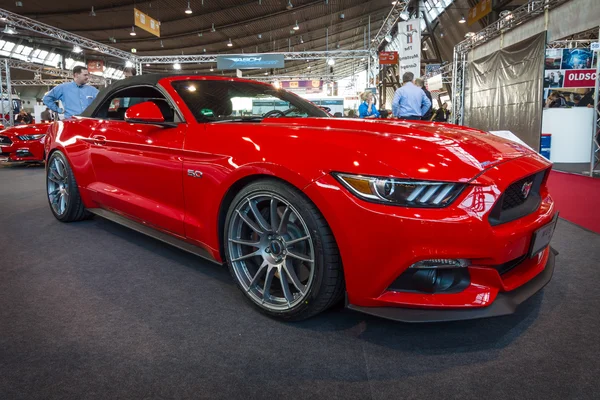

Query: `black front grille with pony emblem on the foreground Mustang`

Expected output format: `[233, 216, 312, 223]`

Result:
[488, 169, 549, 225]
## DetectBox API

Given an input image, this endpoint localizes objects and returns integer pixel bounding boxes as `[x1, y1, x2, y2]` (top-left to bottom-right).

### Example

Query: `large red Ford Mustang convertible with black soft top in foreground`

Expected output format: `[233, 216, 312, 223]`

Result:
[45, 75, 557, 322]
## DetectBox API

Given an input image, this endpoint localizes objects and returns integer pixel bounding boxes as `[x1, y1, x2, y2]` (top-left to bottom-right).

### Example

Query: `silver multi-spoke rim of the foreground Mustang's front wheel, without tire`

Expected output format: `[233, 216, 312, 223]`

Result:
[227, 192, 315, 311]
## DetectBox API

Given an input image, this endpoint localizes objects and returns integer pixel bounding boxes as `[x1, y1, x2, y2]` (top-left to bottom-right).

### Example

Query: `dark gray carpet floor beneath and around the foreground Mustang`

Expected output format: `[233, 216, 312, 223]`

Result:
[0, 166, 600, 400]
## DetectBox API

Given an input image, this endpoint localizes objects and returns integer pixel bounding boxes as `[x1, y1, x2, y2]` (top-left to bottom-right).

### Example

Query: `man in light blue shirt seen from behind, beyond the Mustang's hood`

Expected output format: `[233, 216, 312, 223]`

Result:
[392, 72, 431, 120]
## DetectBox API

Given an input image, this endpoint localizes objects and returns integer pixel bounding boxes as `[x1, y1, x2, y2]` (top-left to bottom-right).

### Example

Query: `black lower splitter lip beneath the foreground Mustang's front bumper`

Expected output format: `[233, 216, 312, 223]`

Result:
[346, 247, 558, 322]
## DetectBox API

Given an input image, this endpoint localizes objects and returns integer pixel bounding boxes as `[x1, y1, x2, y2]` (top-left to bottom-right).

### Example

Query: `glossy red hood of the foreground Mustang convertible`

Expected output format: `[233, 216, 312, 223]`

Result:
[263, 118, 533, 182]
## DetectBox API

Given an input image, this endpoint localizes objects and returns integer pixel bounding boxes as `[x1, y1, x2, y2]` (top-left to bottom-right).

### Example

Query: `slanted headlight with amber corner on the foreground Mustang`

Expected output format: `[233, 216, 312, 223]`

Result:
[333, 173, 466, 208]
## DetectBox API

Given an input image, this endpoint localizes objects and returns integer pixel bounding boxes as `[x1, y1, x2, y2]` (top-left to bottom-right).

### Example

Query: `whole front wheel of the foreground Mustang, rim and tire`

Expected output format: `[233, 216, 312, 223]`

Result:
[224, 179, 344, 321]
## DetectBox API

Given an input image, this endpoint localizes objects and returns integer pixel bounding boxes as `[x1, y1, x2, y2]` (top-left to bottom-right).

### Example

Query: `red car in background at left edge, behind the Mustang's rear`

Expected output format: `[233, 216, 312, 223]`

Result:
[0, 123, 50, 162]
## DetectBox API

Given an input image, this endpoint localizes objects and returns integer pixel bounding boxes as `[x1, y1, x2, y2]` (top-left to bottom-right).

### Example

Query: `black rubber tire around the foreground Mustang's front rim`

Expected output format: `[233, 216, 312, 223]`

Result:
[223, 179, 345, 321]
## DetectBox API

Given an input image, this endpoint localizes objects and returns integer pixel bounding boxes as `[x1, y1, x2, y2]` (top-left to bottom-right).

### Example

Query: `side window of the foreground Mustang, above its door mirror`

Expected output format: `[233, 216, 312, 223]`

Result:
[94, 86, 176, 122]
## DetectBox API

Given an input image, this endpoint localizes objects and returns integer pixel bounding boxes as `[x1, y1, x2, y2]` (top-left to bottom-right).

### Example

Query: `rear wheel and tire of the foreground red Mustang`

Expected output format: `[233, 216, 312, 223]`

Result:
[46, 151, 91, 222]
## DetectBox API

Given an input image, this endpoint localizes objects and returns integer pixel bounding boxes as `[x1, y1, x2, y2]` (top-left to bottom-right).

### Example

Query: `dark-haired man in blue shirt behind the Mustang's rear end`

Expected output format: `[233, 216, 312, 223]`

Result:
[43, 65, 98, 118]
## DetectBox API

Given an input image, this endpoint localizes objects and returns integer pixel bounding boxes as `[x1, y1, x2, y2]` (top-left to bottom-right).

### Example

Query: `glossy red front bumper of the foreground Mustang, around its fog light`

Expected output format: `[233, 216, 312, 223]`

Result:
[305, 155, 556, 320]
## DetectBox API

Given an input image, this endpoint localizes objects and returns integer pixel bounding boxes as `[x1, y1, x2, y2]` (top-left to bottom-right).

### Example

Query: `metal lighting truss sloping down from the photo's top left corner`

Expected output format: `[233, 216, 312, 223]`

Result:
[0, 8, 135, 60]
